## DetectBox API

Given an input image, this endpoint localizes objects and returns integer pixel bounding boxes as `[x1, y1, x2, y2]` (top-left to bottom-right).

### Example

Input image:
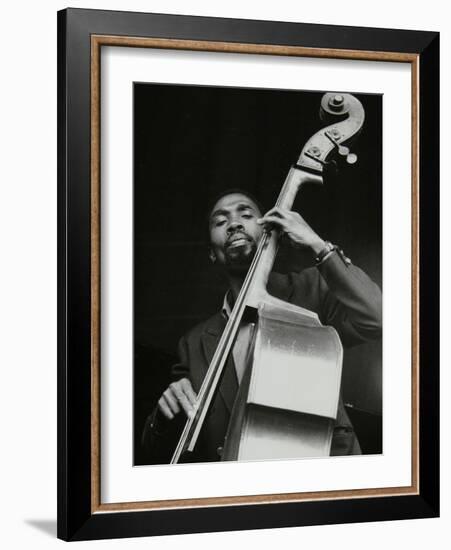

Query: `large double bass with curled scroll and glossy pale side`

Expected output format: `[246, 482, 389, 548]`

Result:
[171, 93, 365, 464]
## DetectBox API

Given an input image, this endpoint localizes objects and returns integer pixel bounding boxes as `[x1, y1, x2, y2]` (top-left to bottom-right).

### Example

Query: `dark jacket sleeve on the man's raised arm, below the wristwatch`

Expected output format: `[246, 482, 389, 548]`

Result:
[304, 251, 382, 347]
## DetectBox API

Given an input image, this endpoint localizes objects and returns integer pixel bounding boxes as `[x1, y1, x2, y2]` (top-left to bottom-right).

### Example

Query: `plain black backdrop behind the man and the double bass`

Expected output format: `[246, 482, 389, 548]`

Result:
[134, 83, 382, 464]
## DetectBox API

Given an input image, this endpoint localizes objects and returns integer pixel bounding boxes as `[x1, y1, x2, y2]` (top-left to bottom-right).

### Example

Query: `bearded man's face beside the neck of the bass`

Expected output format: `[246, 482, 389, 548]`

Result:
[209, 193, 263, 272]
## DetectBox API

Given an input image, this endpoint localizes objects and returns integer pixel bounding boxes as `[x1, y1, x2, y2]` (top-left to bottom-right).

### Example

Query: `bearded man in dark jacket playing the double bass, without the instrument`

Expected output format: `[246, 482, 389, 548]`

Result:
[142, 190, 382, 462]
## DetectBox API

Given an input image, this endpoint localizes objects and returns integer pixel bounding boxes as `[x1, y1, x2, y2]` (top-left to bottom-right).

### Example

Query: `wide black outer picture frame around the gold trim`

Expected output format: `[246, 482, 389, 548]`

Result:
[58, 9, 439, 540]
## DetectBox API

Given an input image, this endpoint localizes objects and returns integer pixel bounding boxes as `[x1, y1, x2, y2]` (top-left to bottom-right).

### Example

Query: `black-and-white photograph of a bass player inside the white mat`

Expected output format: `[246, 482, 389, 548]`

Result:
[133, 82, 383, 465]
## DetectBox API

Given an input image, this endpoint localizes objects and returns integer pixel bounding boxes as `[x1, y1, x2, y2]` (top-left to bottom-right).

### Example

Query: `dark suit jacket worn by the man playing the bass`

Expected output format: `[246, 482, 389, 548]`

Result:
[142, 252, 382, 462]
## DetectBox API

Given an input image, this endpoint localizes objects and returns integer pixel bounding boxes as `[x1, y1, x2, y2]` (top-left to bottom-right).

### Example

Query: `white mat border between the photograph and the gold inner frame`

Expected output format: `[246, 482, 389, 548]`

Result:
[100, 46, 412, 504]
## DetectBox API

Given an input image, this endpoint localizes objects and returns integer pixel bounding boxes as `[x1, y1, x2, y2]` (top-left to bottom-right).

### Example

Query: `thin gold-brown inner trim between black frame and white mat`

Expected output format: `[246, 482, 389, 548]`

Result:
[90, 35, 420, 514]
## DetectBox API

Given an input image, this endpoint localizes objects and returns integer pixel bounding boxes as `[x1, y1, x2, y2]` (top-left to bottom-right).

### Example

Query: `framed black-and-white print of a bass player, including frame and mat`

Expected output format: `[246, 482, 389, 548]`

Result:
[58, 9, 439, 540]
